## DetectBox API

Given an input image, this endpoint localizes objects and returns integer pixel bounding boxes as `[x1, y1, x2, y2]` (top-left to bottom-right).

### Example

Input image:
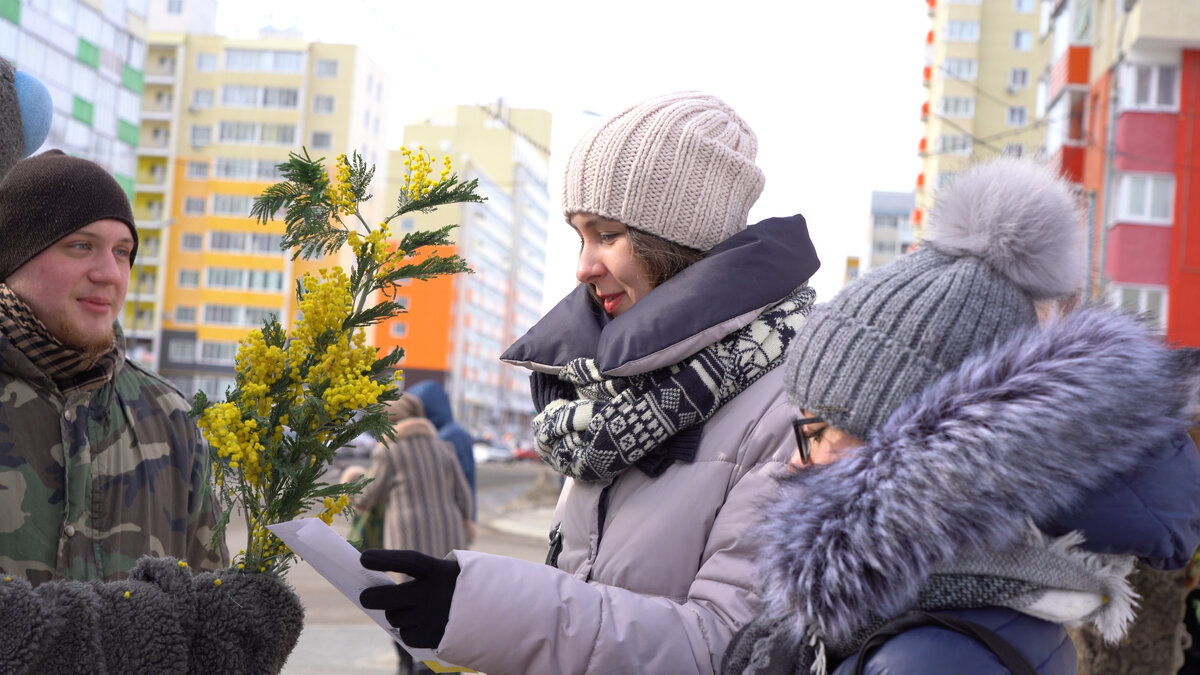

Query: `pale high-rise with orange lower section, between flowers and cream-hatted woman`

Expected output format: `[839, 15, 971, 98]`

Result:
[376, 102, 551, 437]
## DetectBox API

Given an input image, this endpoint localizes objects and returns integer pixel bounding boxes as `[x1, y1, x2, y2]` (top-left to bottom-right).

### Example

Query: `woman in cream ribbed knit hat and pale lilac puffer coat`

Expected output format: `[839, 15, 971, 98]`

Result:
[362, 91, 818, 675]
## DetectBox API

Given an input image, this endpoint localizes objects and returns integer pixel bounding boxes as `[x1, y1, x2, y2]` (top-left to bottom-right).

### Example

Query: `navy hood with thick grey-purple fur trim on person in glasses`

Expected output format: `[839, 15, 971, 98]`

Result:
[758, 307, 1200, 641]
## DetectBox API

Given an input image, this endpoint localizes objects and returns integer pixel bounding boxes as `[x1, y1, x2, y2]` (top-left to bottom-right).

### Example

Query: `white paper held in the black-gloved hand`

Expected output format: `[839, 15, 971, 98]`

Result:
[266, 518, 467, 673]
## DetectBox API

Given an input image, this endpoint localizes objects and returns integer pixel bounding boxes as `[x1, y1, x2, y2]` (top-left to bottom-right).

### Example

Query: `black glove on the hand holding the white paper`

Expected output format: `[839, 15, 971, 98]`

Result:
[359, 549, 460, 649]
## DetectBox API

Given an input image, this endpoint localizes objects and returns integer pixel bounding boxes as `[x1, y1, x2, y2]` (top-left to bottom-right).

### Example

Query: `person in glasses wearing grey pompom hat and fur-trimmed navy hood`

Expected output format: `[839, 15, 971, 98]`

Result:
[722, 159, 1200, 675]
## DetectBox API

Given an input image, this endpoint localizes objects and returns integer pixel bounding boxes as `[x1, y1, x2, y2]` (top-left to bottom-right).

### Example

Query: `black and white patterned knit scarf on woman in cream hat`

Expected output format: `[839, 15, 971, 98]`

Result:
[533, 286, 816, 480]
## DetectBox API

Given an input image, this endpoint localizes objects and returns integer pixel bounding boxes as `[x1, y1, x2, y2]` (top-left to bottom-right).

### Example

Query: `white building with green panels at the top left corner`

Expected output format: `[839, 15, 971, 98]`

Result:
[0, 0, 152, 357]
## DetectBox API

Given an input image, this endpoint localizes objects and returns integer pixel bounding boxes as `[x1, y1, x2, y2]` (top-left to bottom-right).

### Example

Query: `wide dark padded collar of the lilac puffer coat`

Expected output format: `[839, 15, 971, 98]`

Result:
[500, 215, 821, 376]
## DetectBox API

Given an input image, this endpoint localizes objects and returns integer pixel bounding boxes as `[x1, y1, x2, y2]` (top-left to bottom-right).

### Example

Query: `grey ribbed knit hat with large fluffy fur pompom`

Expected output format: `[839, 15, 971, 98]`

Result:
[785, 157, 1082, 440]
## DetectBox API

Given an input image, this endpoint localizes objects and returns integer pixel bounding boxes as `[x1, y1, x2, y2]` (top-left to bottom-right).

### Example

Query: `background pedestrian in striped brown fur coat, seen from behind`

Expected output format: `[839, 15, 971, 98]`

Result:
[354, 394, 475, 675]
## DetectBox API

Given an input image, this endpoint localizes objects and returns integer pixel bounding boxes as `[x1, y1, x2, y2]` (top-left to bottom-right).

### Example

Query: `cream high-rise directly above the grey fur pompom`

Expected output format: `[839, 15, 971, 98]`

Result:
[912, 0, 1045, 229]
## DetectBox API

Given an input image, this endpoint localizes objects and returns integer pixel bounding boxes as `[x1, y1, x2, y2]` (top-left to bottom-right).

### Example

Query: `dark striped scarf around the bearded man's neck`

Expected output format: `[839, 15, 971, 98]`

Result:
[0, 283, 124, 394]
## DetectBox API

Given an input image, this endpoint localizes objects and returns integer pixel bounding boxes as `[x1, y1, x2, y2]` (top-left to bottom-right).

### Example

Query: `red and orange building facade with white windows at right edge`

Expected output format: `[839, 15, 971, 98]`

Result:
[1042, 0, 1200, 338]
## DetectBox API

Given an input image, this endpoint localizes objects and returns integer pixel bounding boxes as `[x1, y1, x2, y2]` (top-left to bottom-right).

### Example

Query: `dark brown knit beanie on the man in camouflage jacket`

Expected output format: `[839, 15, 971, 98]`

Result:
[0, 150, 138, 280]
